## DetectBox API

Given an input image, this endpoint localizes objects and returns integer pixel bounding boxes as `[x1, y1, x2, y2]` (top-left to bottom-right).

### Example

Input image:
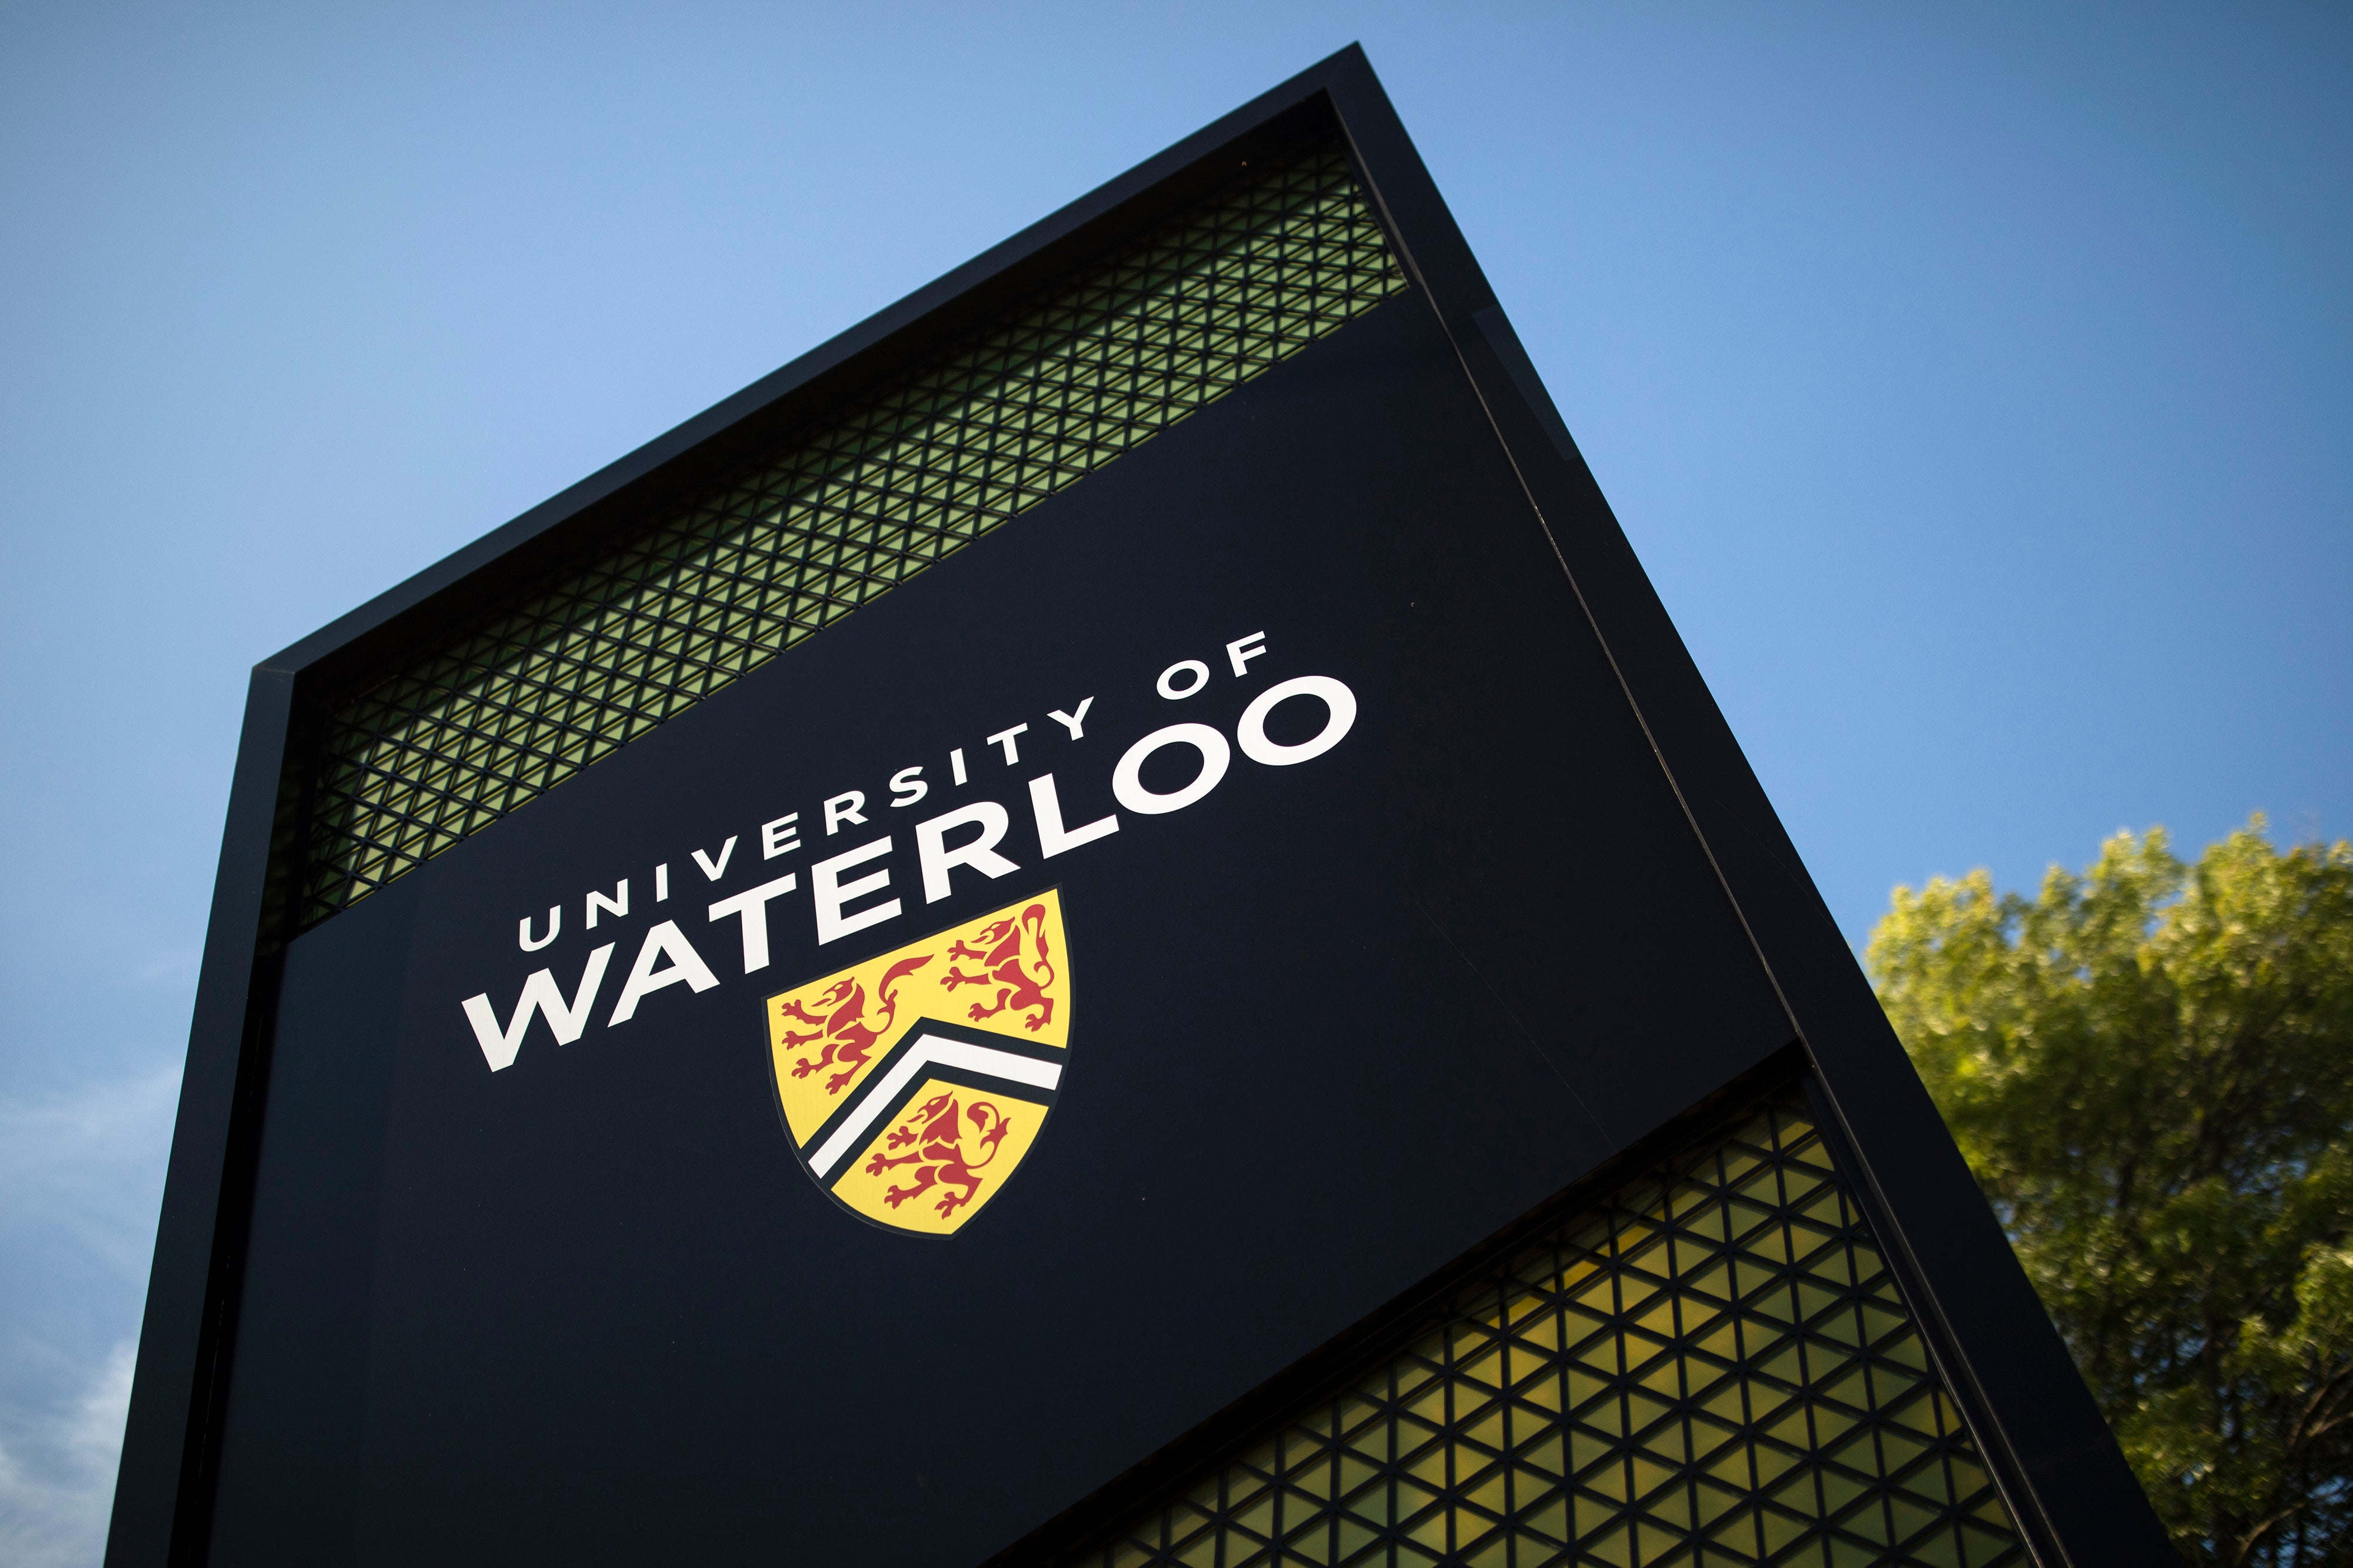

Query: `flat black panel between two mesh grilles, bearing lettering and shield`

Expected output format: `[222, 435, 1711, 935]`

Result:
[214, 296, 1788, 1566]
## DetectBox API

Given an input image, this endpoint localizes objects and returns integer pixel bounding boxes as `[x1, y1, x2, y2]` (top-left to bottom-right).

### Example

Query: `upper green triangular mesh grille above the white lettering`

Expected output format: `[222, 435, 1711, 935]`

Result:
[292, 146, 1407, 925]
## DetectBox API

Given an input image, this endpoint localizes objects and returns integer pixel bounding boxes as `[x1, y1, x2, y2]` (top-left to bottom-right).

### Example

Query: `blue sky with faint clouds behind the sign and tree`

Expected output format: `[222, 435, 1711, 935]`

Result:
[0, 0, 2353, 1563]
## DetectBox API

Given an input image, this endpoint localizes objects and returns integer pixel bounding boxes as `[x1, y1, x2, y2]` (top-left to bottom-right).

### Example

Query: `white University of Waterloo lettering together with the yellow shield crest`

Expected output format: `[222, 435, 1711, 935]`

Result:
[452, 631, 1358, 1236]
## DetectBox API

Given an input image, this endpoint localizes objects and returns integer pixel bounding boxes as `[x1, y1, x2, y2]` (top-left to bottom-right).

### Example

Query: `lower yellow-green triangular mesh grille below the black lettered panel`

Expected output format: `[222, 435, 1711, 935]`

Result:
[1082, 1097, 2031, 1568]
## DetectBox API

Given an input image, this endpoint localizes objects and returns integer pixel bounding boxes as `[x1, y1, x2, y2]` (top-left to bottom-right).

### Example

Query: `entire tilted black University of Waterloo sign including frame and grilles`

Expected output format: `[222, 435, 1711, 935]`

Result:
[108, 49, 2162, 1568]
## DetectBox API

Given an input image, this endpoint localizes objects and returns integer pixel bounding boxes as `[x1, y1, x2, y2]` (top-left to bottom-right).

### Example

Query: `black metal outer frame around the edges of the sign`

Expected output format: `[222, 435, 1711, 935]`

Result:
[106, 45, 2169, 1568]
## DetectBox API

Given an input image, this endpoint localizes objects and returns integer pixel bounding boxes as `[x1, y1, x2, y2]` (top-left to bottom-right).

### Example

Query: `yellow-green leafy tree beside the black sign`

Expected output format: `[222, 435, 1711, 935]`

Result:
[1868, 817, 2353, 1568]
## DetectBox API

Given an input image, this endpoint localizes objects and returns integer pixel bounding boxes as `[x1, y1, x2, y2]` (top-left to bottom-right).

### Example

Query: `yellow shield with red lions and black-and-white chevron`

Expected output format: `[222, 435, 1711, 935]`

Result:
[767, 890, 1071, 1236]
